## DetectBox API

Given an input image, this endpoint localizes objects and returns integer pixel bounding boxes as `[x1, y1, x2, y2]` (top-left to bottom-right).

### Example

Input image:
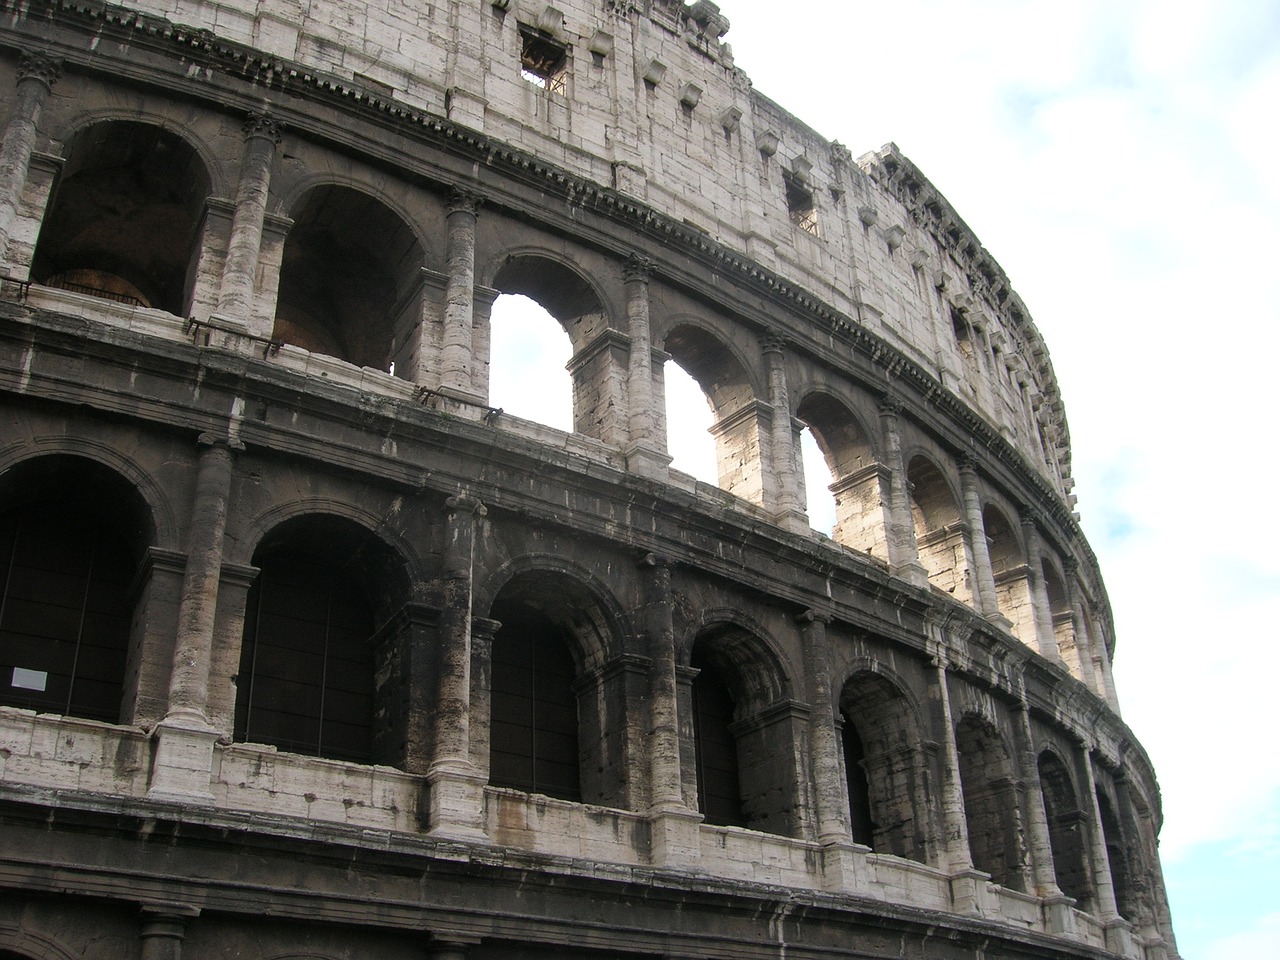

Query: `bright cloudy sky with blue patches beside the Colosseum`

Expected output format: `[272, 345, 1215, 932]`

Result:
[494, 0, 1280, 960]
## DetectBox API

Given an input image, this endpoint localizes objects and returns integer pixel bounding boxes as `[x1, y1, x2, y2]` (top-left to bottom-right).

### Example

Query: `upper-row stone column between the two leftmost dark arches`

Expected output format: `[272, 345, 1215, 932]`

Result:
[216, 114, 282, 328]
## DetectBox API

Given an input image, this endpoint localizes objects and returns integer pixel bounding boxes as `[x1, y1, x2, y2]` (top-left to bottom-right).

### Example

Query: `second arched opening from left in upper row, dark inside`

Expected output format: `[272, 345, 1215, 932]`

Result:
[273, 184, 422, 376]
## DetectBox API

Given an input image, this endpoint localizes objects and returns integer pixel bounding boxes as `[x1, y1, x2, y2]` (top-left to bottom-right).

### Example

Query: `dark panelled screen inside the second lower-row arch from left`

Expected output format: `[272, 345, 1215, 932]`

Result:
[236, 553, 374, 763]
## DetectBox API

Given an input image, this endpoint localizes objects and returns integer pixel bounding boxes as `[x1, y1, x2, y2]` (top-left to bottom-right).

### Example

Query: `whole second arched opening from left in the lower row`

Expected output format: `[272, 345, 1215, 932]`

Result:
[234, 516, 407, 764]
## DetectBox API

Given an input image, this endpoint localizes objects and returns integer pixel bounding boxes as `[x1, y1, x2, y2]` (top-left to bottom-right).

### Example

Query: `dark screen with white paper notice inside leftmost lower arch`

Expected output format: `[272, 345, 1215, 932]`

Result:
[0, 504, 133, 723]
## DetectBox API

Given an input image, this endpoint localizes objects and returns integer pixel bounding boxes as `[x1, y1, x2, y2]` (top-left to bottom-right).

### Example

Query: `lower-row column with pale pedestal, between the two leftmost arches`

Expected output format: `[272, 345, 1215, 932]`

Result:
[147, 434, 243, 801]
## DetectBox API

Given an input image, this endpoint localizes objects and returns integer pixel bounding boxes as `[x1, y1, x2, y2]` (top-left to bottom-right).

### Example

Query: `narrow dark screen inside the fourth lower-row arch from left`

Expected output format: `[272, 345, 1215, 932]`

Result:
[692, 657, 746, 827]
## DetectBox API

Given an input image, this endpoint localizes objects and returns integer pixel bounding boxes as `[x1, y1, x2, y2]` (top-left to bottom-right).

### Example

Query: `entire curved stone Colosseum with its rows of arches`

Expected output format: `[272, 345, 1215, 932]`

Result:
[0, 0, 1178, 960]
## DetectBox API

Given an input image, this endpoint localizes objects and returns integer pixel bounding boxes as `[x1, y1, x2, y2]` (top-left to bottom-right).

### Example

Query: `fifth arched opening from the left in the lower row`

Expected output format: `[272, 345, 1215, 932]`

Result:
[840, 671, 928, 863]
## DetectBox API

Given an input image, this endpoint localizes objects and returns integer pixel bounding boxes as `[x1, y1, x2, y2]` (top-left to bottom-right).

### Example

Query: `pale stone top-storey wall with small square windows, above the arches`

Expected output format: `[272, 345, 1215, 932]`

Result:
[90, 0, 1073, 504]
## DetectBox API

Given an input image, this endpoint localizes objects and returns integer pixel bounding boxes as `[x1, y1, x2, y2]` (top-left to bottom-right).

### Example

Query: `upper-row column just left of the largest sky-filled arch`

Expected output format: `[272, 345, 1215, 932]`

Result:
[440, 189, 483, 403]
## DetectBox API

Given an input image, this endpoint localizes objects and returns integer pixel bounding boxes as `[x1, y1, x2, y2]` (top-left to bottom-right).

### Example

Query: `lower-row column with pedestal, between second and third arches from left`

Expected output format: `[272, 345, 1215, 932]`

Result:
[426, 494, 486, 838]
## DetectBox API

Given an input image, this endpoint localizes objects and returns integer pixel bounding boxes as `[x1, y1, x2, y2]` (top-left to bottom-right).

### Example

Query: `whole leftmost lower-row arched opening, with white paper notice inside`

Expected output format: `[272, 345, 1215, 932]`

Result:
[0, 456, 154, 723]
